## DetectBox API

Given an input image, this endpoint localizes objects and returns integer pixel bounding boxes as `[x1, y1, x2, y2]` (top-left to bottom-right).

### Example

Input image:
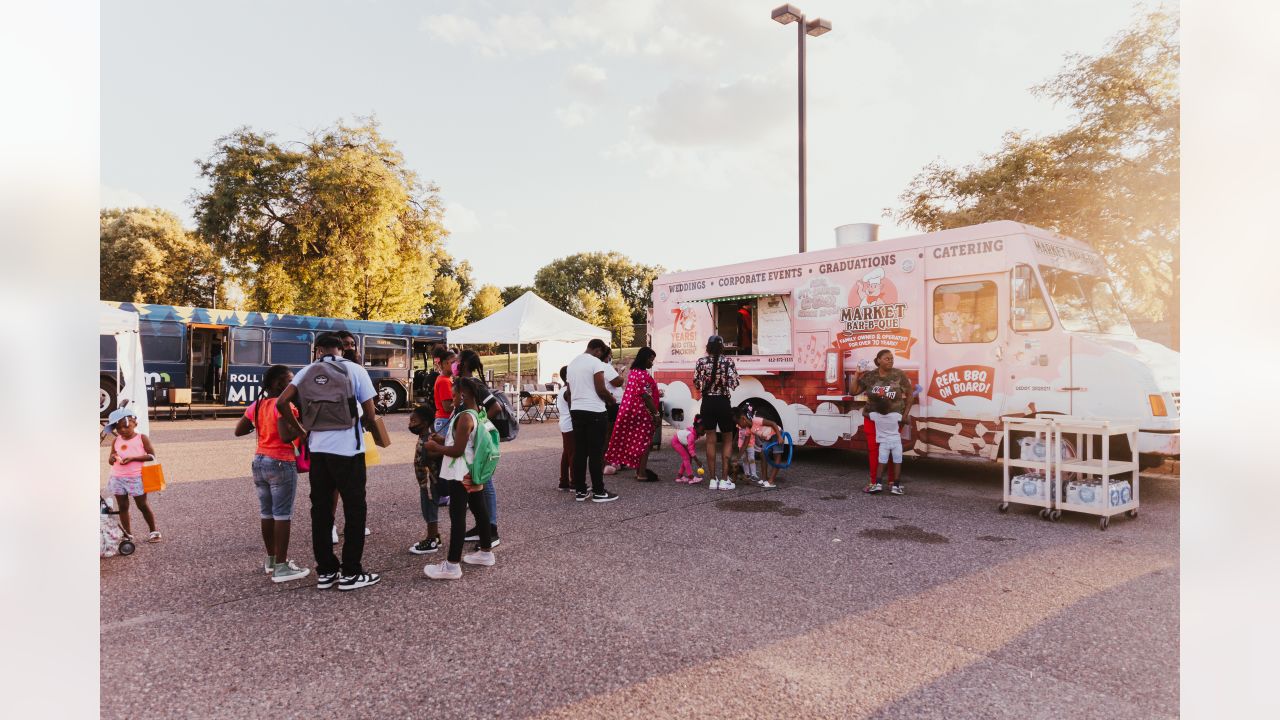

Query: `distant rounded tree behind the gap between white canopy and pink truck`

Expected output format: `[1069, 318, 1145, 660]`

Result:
[534, 251, 663, 323]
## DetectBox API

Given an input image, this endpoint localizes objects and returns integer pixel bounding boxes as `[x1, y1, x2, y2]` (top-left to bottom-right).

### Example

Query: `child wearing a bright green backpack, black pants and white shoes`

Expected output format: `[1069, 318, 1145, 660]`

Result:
[422, 378, 499, 580]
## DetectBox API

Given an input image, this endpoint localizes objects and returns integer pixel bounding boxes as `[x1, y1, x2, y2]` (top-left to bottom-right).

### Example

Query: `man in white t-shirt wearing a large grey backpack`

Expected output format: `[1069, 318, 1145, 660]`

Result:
[276, 333, 381, 591]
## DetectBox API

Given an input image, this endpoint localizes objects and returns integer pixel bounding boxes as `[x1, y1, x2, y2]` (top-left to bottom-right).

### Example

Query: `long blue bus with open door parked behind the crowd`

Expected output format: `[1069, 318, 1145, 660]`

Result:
[99, 302, 448, 416]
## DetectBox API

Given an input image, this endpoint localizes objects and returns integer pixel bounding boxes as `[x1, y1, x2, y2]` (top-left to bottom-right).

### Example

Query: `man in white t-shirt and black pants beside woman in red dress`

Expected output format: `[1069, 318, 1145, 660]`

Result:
[566, 338, 618, 502]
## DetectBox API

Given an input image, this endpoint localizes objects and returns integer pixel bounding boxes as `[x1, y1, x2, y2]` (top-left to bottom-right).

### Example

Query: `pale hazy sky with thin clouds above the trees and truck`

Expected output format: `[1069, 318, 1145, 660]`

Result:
[101, 0, 1176, 292]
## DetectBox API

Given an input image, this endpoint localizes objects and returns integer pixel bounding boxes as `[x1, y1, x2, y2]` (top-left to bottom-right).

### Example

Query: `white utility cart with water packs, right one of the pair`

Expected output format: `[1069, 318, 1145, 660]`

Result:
[1052, 418, 1138, 530]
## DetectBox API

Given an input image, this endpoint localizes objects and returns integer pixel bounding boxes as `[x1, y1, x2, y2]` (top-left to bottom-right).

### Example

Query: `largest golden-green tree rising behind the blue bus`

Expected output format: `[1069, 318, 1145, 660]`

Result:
[192, 120, 445, 322]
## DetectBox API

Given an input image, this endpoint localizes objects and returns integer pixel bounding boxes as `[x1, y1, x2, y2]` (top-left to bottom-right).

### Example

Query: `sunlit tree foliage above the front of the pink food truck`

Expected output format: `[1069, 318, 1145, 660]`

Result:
[887, 10, 1180, 325]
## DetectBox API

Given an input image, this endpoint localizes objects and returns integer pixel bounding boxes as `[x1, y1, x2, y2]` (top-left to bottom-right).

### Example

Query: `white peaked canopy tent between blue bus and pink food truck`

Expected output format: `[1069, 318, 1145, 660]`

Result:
[448, 291, 609, 380]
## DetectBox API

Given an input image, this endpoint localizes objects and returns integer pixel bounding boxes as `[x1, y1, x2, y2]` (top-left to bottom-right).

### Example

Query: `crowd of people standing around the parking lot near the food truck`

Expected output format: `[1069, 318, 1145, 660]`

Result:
[102, 333, 916, 591]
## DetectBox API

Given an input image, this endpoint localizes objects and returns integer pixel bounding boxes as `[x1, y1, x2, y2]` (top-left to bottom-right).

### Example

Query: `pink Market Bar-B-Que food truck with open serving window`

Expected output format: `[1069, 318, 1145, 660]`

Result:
[649, 220, 1180, 465]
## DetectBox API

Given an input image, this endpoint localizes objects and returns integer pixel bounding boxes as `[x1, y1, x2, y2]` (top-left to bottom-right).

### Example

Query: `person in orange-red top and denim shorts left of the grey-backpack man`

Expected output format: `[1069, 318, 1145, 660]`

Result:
[236, 365, 311, 583]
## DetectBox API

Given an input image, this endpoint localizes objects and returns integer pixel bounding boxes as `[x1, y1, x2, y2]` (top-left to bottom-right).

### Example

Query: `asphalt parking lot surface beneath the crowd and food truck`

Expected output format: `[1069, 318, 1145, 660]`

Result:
[101, 414, 1179, 719]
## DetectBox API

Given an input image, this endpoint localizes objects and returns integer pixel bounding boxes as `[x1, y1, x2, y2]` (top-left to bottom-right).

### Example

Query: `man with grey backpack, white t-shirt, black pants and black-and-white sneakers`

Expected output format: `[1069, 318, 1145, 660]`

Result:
[276, 333, 381, 591]
